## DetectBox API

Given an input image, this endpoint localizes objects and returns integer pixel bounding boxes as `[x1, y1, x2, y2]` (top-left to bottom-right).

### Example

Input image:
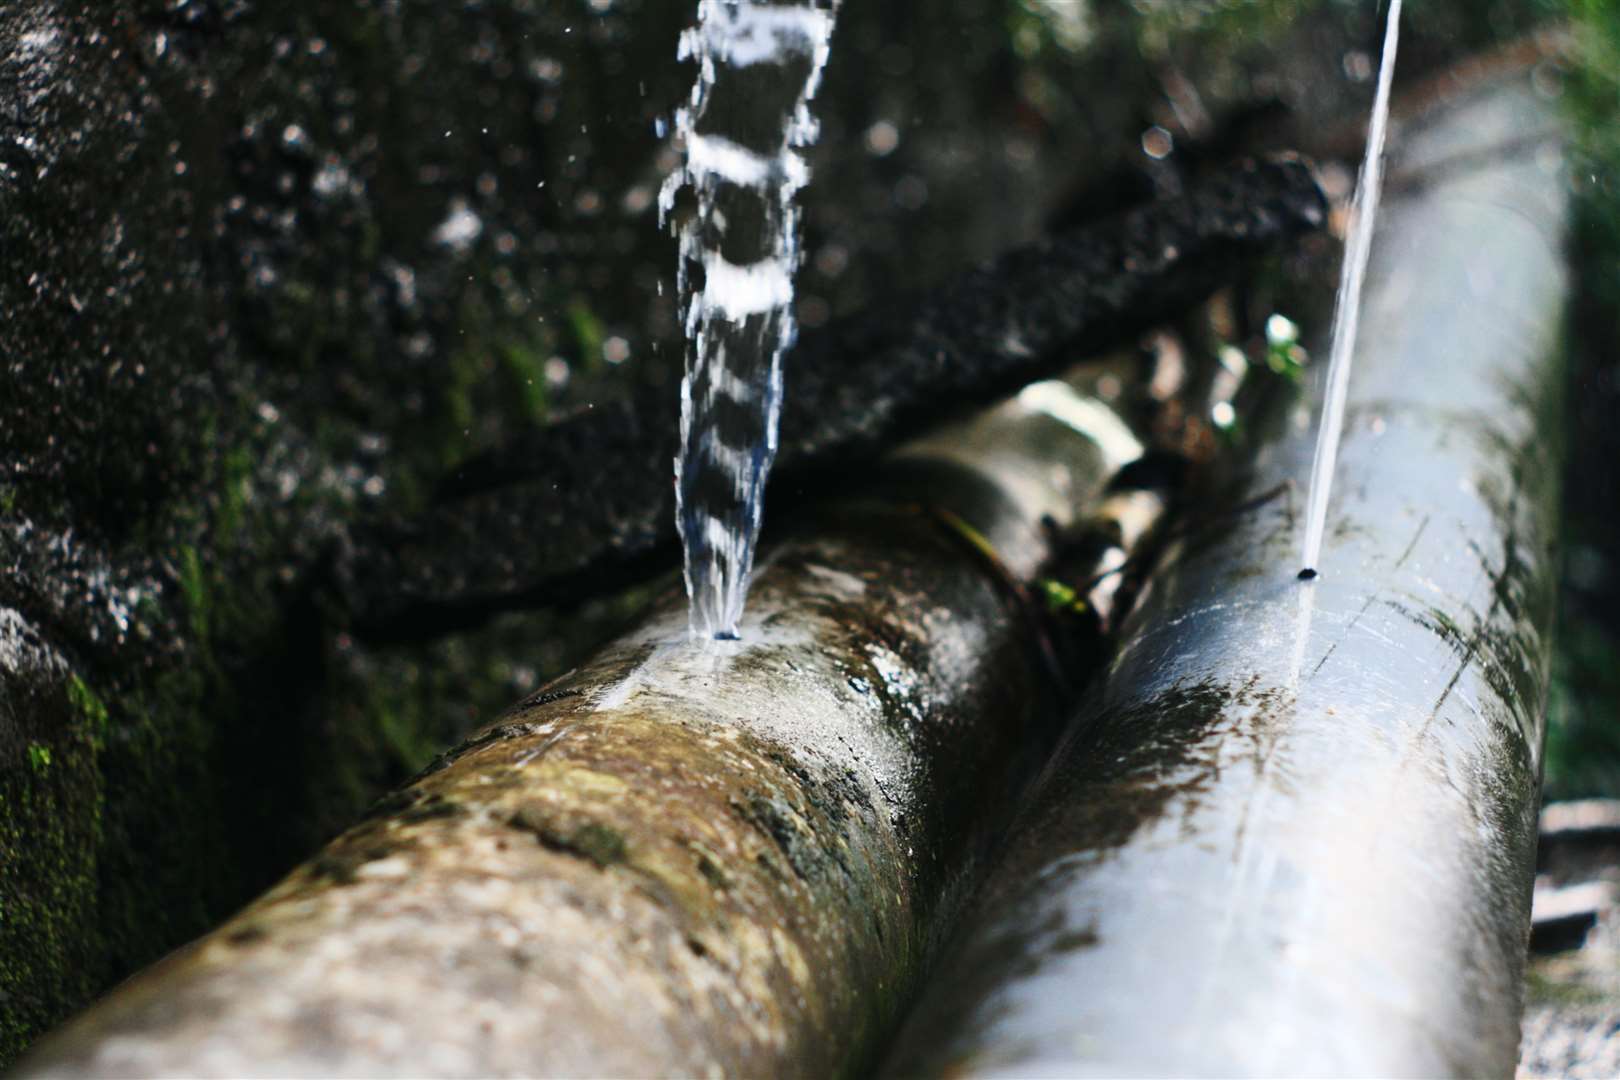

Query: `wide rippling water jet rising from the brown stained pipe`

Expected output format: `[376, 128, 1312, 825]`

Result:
[659, 0, 839, 640]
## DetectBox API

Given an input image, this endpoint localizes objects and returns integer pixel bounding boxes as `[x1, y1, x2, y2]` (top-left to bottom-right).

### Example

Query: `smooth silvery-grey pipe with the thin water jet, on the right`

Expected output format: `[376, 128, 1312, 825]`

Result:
[891, 71, 1568, 1077]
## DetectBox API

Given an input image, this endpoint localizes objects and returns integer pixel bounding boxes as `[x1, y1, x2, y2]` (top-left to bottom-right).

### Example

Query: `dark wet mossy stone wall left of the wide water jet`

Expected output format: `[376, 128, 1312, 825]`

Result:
[0, 0, 696, 1061]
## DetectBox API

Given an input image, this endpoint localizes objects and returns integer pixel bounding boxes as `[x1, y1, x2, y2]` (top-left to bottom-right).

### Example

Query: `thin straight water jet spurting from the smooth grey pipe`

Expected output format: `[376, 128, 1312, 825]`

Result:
[1299, 0, 1401, 581]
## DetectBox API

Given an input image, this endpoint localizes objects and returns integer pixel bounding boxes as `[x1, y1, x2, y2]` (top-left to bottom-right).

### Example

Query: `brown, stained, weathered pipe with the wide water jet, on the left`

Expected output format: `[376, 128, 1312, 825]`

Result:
[19, 369, 1140, 1077]
